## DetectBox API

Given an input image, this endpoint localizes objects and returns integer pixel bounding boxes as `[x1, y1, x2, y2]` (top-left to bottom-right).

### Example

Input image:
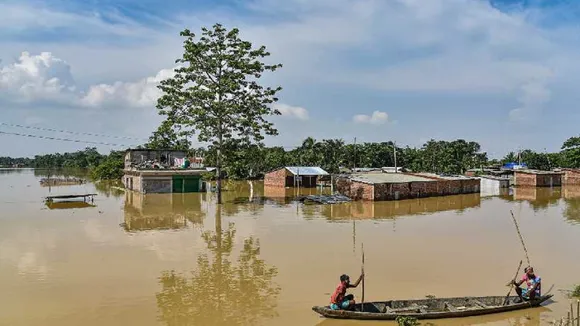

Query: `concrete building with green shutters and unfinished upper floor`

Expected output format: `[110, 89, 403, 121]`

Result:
[123, 149, 207, 193]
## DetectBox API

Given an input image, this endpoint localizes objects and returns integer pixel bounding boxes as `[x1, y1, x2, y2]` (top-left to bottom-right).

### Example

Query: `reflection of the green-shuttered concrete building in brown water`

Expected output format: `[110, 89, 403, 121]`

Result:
[121, 191, 205, 232]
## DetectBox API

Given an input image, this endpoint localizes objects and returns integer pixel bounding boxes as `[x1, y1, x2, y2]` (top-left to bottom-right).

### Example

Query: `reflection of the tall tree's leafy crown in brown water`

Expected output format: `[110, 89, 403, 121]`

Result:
[156, 208, 280, 326]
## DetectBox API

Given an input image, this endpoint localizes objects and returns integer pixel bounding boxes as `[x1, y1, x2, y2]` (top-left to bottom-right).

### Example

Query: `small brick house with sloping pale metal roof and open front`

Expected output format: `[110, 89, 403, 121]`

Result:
[264, 166, 329, 188]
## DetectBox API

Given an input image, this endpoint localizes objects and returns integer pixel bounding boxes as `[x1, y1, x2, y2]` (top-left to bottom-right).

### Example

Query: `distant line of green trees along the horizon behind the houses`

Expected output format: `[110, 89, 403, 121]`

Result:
[0, 137, 580, 179]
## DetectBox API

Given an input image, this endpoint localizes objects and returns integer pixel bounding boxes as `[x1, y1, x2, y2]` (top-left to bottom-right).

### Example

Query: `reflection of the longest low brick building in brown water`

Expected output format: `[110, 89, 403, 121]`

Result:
[304, 194, 481, 220]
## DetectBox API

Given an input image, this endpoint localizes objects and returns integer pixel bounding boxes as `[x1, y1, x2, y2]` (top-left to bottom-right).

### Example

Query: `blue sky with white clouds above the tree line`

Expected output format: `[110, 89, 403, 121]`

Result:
[0, 0, 580, 157]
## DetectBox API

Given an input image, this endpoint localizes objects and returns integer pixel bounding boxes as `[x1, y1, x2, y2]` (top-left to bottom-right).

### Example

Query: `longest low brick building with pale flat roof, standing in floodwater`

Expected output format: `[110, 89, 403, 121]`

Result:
[336, 173, 480, 201]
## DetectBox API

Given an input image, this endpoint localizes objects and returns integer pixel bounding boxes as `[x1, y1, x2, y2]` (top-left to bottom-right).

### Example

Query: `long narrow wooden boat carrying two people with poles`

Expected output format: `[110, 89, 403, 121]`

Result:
[312, 294, 553, 320]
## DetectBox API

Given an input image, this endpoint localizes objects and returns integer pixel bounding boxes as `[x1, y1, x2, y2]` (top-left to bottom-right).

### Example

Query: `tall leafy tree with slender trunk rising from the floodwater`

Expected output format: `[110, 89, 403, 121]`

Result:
[157, 24, 282, 204]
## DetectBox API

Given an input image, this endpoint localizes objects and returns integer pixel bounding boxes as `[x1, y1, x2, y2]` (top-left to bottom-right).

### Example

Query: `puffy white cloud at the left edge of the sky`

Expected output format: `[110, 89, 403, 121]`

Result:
[0, 52, 75, 102]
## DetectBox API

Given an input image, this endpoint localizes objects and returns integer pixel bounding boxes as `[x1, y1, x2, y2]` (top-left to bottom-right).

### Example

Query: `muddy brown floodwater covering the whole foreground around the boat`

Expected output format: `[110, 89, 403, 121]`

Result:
[0, 170, 580, 326]
